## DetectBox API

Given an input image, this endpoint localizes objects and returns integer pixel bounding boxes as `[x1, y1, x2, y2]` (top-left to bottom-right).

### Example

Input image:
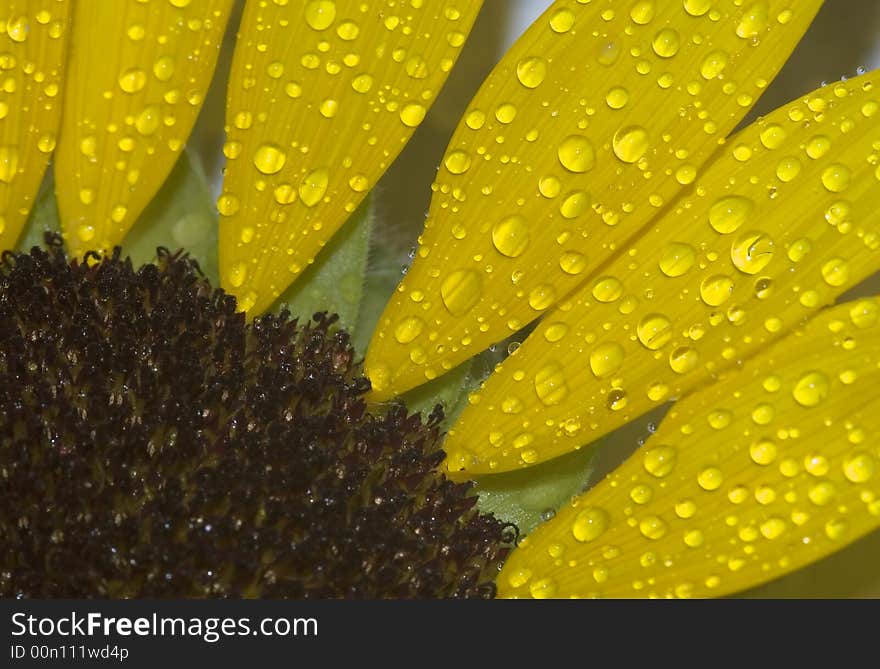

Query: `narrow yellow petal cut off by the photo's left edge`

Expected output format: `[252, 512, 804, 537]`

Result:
[0, 0, 70, 251]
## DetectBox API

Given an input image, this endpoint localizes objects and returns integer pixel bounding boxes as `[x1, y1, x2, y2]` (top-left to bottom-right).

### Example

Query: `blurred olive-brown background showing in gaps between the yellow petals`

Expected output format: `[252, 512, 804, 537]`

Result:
[191, 0, 880, 597]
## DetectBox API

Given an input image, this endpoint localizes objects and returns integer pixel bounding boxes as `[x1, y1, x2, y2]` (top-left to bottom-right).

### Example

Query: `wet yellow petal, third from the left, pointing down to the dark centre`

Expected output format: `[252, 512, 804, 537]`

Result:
[217, 0, 482, 314]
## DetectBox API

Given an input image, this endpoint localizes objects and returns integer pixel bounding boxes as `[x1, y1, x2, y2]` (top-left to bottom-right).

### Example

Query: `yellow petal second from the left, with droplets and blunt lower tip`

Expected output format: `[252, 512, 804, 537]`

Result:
[55, 0, 232, 255]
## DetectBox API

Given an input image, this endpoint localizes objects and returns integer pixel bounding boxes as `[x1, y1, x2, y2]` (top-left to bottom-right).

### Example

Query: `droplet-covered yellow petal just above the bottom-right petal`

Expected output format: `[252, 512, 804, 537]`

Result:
[446, 73, 880, 473]
